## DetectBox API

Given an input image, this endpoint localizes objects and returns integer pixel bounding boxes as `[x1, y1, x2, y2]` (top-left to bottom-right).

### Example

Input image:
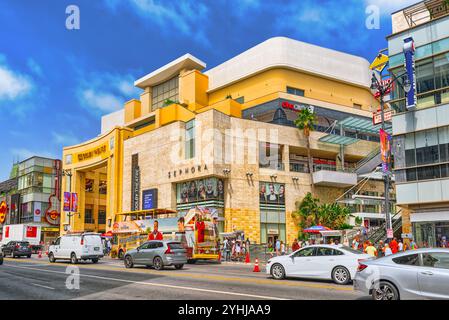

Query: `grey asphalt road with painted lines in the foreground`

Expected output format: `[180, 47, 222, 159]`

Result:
[0, 257, 367, 300]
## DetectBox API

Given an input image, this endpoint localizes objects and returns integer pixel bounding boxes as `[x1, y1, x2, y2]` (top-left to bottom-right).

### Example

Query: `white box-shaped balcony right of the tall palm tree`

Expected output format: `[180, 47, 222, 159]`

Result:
[313, 164, 357, 188]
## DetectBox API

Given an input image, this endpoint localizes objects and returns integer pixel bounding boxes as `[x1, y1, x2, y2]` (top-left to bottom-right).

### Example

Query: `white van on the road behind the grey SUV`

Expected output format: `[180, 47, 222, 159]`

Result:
[48, 233, 104, 264]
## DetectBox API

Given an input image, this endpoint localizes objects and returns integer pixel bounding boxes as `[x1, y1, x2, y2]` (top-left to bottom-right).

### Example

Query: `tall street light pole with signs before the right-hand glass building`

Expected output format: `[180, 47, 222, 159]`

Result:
[371, 72, 410, 239]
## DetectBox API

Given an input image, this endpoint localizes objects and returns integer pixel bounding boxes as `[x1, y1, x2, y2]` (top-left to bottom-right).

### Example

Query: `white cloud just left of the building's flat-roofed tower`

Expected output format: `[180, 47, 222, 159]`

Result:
[76, 72, 140, 114]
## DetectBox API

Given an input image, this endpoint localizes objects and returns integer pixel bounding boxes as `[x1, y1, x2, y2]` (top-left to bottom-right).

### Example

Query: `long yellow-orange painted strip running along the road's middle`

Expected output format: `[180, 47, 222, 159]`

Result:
[3, 260, 354, 293]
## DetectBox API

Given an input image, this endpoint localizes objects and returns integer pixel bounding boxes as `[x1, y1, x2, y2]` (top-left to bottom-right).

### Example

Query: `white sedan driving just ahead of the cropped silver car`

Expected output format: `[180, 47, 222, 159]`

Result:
[266, 245, 372, 284]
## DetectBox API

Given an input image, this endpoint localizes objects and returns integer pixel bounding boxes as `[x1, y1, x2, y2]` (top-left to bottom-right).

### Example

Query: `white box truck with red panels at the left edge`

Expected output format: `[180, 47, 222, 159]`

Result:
[1, 224, 41, 253]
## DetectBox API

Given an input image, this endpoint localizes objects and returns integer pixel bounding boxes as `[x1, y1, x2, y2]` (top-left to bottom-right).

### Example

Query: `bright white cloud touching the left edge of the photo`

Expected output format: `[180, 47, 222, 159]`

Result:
[0, 58, 34, 100]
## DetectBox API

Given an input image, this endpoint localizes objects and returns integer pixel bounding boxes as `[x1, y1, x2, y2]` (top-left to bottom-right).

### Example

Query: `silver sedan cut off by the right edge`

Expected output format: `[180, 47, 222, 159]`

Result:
[353, 249, 449, 300]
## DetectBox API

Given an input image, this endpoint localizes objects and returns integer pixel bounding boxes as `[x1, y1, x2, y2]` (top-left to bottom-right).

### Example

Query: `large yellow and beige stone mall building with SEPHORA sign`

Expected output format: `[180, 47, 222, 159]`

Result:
[61, 37, 379, 243]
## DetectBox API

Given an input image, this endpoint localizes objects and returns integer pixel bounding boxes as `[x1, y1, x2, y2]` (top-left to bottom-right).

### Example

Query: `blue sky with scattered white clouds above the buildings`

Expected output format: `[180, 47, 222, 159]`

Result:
[0, 0, 417, 180]
